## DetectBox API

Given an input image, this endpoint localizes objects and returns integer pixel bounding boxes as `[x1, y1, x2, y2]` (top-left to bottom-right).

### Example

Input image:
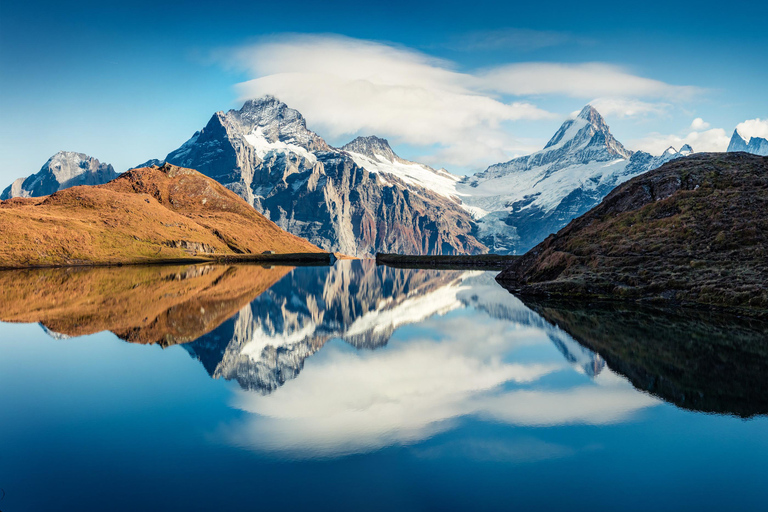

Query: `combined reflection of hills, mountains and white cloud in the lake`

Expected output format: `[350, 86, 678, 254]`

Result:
[0, 260, 768, 457]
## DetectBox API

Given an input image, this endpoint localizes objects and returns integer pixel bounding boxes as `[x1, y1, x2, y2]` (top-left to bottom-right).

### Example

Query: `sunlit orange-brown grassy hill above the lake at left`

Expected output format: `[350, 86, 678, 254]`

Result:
[0, 164, 320, 267]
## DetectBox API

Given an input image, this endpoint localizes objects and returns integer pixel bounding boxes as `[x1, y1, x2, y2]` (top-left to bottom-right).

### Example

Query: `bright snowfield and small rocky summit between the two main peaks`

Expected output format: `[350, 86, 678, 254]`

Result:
[341, 136, 461, 198]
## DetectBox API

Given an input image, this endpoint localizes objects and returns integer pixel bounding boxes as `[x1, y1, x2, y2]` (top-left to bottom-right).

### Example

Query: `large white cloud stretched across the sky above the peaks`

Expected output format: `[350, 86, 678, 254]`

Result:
[220, 34, 695, 168]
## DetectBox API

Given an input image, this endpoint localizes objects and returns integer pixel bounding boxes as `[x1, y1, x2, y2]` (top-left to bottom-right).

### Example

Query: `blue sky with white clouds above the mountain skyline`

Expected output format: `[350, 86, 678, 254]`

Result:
[0, 1, 768, 181]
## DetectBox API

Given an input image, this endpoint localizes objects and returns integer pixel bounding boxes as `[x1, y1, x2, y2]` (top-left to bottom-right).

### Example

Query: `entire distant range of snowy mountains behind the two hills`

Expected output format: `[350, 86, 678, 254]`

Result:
[2, 96, 768, 257]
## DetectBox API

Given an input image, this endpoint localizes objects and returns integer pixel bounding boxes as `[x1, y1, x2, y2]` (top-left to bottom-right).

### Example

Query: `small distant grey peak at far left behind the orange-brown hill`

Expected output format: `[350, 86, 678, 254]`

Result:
[0, 151, 118, 200]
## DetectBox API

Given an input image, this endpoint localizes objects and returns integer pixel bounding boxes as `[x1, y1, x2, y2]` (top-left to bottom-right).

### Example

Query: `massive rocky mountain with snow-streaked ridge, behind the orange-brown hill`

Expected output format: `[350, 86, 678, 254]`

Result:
[151, 96, 487, 256]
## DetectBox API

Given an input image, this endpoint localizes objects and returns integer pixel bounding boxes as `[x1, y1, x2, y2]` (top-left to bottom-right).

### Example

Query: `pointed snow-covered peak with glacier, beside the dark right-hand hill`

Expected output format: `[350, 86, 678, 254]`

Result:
[457, 105, 693, 254]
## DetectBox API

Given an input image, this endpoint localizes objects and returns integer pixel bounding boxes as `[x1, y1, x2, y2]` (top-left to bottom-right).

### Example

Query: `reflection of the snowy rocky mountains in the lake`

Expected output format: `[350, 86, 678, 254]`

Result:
[183, 260, 604, 394]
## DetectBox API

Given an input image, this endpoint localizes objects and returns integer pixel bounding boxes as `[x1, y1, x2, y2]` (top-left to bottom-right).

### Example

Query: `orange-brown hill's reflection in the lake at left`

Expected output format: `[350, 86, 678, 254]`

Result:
[0, 265, 292, 346]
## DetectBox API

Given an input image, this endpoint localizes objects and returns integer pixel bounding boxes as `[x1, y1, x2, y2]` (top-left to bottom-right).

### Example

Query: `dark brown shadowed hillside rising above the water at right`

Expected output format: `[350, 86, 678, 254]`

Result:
[498, 153, 768, 315]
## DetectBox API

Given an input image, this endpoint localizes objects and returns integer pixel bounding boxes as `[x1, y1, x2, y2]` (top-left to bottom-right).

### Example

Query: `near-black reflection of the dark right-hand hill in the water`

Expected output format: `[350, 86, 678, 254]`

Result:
[526, 300, 768, 417]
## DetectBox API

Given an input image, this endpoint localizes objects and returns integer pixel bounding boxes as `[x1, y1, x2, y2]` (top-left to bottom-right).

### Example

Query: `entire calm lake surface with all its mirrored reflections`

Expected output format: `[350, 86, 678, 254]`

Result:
[0, 261, 768, 512]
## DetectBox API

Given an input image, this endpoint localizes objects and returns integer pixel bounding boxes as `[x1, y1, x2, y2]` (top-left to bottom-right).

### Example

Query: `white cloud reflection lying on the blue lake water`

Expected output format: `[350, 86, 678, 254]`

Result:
[220, 308, 658, 457]
